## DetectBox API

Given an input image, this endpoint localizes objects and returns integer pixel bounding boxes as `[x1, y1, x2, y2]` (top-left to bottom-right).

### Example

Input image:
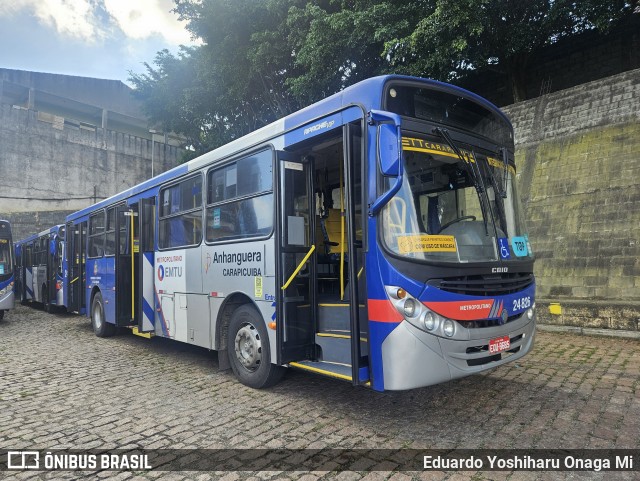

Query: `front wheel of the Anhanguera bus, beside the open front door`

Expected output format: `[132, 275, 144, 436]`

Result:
[227, 304, 285, 389]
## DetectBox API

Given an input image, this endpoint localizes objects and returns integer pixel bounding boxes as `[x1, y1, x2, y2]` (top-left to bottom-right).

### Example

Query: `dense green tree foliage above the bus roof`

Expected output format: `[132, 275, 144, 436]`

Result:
[130, 0, 633, 155]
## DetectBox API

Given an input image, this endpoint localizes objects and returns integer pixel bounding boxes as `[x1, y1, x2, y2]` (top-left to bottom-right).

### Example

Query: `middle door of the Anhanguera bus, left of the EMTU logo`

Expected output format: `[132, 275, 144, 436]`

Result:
[115, 203, 138, 326]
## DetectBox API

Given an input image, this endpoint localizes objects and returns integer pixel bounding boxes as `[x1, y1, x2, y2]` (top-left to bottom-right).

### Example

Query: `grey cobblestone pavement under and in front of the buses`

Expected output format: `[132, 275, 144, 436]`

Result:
[0, 306, 640, 481]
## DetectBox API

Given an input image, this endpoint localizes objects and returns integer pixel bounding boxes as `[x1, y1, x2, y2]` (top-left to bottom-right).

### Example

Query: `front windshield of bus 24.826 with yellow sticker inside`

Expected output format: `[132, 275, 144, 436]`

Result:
[382, 134, 532, 262]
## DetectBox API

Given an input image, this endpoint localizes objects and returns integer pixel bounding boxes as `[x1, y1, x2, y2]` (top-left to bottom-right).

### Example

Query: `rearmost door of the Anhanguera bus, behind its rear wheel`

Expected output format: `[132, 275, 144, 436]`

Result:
[65, 221, 87, 313]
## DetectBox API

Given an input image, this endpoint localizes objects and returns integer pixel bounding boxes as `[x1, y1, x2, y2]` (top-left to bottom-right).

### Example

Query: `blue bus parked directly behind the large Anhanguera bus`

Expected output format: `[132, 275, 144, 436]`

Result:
[14, 225, 67, 312]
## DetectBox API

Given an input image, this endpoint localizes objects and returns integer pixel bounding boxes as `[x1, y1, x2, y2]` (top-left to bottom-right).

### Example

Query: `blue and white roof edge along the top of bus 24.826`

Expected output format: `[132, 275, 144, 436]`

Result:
[66, 75, 511, 222]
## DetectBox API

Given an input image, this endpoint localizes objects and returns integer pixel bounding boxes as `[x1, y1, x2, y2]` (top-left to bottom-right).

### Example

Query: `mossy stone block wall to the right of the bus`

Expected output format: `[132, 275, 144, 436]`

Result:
[505, 69, 640, 330]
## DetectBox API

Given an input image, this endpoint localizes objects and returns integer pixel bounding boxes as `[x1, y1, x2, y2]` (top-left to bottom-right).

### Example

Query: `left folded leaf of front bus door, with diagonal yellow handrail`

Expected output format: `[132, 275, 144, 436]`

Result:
[276, 152, 316, 364]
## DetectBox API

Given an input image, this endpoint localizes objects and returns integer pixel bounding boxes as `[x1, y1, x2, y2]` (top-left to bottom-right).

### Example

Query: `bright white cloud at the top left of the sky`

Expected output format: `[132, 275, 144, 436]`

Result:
[0, 0, 192, 45]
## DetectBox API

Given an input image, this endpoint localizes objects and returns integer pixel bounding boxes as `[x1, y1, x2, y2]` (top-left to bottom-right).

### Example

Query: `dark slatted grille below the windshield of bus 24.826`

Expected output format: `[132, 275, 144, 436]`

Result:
[427, 272, 534, 296]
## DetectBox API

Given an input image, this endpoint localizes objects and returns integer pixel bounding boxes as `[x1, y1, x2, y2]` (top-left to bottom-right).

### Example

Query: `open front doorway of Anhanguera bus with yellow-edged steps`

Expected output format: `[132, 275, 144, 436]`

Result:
[276, 121, 369, 385]
